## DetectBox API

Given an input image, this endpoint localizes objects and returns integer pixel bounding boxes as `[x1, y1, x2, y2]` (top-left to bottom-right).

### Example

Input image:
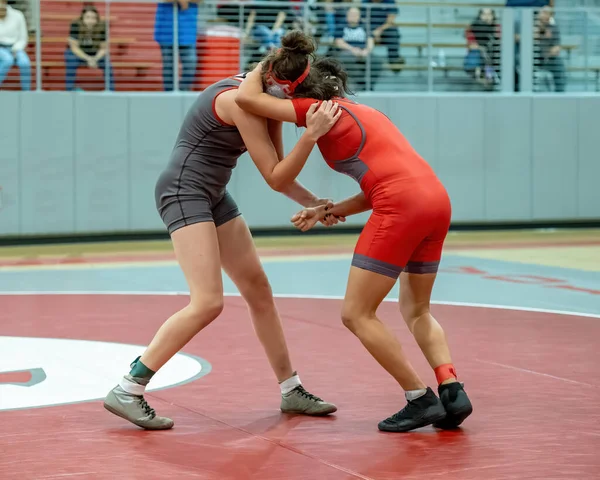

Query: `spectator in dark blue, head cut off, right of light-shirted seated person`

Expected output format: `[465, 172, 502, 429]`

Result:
[362, 0, 404, 72]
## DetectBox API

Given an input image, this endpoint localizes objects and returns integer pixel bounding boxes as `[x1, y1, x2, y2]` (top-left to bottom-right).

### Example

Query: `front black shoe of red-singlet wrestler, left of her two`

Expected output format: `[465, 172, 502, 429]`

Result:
[378, 387, 446, 432]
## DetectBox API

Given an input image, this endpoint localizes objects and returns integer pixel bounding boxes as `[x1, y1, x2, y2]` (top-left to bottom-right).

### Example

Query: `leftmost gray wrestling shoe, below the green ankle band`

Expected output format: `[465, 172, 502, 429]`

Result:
[104, 375, 174, 430]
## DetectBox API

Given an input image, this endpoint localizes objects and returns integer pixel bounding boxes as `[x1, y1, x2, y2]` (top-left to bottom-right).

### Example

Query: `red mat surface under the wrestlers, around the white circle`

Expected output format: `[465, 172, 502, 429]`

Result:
[0, 295, 600, 480]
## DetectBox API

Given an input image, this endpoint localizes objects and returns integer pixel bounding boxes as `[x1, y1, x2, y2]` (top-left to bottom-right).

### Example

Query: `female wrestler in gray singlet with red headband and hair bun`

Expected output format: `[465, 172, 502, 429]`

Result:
[104, 32, 341, 430]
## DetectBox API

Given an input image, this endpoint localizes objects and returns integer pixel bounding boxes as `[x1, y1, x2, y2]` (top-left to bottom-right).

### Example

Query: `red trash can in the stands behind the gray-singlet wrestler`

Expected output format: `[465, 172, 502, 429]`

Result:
[196, 25, 241, 89]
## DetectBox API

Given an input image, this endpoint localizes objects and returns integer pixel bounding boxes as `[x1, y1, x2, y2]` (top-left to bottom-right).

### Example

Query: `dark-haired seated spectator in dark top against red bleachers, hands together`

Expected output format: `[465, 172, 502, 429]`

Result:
[65, 5, 115, 92]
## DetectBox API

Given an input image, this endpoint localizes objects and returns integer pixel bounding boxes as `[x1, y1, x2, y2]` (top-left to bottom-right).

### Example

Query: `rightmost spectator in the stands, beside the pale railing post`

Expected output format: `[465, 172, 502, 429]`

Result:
[533, 7, 566, 92]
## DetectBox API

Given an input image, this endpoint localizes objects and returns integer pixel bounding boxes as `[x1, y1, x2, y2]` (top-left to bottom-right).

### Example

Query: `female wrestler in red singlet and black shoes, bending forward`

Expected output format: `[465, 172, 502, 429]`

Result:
[236, 43, 472, 432]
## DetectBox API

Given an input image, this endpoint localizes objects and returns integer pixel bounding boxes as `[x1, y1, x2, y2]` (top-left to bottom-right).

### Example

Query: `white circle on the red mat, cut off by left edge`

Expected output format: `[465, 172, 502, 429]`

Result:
[0, 336, 210, 410]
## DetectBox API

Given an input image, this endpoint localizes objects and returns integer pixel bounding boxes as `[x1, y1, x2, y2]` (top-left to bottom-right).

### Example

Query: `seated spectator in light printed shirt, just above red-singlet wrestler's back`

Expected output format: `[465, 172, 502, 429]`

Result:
[335, 7, 381, 91]
